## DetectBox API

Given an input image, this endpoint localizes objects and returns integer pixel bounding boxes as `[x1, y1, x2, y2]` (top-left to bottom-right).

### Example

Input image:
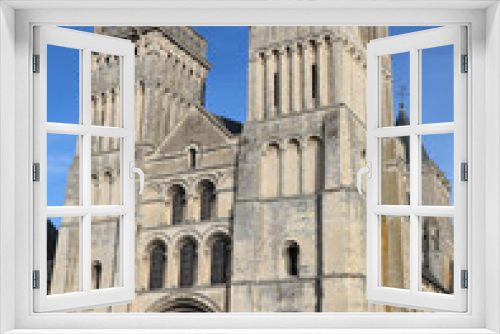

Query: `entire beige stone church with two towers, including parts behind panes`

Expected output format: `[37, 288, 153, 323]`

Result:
[50, 27, 453, 312]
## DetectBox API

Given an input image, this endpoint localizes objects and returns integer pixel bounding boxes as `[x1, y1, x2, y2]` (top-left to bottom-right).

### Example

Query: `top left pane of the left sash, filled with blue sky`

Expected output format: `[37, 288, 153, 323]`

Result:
[47, 45, 80, 124]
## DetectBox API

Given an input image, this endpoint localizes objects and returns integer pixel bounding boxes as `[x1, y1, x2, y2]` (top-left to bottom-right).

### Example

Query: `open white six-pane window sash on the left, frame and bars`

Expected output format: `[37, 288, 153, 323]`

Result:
[33, 26, 135, 313]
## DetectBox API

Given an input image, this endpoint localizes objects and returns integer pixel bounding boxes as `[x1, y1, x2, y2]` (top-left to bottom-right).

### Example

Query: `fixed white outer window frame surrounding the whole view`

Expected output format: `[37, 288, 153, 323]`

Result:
[0, 1, 500, 333]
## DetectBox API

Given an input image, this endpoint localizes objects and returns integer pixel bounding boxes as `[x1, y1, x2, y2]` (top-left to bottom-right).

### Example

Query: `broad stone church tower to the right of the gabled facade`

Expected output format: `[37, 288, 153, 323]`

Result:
[231, 27, 392, 312]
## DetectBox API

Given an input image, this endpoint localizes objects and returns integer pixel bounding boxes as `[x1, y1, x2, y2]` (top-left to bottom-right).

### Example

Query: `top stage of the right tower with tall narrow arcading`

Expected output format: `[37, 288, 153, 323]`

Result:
[248, 27, 388, 121]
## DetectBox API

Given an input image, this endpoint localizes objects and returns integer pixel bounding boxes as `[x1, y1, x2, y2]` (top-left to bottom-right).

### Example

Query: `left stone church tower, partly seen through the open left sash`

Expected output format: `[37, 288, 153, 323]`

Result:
[49, 27, 211, 306]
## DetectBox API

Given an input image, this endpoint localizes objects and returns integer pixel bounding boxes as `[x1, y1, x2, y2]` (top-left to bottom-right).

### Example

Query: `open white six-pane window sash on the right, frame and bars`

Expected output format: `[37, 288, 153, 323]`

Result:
[366, 25, 468, 312]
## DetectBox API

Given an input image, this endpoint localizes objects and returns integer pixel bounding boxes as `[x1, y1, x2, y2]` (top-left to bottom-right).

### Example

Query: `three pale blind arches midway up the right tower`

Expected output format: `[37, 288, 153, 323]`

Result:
[260, 137, 321, 198]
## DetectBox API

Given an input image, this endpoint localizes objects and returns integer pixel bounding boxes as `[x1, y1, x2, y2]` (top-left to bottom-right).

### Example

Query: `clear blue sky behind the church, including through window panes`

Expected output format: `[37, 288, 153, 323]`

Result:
[47, 27, 453, 222]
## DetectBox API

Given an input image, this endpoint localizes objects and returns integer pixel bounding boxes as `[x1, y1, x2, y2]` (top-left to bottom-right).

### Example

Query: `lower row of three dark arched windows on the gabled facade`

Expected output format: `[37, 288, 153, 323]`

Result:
[148, 235, 231, 291]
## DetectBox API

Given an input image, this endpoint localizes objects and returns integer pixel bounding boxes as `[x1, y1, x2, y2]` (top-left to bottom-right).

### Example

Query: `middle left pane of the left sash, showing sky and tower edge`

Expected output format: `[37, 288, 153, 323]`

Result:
[47, 133, 81, 206]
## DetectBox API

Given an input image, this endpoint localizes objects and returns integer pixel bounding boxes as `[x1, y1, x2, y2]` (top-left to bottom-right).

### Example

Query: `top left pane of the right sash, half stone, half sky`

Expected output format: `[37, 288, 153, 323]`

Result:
[380, 52, 410, 127]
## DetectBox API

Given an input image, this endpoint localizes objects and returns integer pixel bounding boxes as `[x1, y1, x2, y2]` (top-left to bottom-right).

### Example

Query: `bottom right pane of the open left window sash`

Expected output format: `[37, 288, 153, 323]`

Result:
[91, 216, 121, 290]
